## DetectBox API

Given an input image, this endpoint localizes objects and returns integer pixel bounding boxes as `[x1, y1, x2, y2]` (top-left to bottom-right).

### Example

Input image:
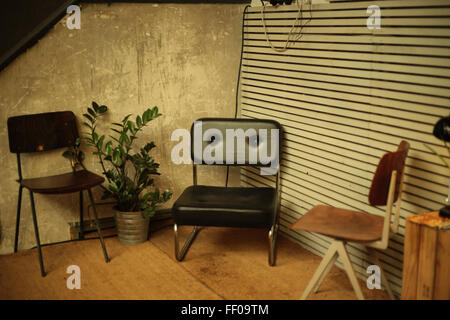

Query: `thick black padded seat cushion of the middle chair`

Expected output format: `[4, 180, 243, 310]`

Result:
[172, 186, 276, 228]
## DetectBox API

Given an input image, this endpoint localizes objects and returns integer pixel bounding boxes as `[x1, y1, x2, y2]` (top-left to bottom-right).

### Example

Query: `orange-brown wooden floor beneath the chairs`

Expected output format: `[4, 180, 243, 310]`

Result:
[0, 228, 388, 300]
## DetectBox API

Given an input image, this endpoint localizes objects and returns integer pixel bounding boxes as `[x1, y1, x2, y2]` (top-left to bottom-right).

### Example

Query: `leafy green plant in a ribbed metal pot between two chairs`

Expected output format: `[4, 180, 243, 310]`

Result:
[65, 102, 172, 244]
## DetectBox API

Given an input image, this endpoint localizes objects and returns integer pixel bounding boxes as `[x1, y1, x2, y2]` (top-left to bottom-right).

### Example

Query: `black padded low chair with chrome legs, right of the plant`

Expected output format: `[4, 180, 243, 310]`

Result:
[172, 118, 282, 266]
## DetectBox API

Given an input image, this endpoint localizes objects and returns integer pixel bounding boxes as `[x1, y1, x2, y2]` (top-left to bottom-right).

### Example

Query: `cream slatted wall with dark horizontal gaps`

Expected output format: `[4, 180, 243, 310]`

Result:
[240, 0, 450, 295]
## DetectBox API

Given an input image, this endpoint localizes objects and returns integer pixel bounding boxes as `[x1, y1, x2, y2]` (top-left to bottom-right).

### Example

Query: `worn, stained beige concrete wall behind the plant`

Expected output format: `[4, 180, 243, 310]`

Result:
[0, 4, 243, 253]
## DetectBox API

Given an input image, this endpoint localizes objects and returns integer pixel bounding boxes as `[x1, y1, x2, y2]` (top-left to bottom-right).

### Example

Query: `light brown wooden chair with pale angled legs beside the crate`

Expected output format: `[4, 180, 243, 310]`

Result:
[290, 141, 409, 300]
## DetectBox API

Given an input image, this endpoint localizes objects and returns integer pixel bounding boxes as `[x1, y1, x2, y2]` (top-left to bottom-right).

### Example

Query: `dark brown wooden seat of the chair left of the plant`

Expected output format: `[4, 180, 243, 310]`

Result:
[19, 170, 105, 194]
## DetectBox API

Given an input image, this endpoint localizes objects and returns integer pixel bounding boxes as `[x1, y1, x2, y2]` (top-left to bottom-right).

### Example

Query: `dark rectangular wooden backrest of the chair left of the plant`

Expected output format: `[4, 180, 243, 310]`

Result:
[8, 111, 78, 153]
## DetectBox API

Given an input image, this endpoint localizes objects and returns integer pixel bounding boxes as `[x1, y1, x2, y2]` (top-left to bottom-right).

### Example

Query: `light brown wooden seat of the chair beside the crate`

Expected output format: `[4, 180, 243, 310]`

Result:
[290, 205, 384, 242]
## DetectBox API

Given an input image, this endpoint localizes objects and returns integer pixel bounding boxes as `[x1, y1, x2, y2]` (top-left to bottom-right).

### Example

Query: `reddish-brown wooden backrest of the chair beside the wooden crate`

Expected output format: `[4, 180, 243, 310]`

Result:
[369, 140, 409, 206]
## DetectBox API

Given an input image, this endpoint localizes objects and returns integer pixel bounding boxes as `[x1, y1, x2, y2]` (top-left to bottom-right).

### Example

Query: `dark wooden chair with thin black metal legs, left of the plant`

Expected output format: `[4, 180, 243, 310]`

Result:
[8, 111, 109, 277]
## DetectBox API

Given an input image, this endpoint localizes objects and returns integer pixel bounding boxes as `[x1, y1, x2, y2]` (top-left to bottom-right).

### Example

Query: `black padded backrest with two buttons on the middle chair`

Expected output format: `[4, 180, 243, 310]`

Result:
[191, 118, 282, 169]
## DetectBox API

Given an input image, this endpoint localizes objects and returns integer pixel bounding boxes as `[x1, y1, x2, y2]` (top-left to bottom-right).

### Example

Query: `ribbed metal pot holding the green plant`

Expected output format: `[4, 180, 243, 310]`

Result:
[114, 210, 150, 244]
